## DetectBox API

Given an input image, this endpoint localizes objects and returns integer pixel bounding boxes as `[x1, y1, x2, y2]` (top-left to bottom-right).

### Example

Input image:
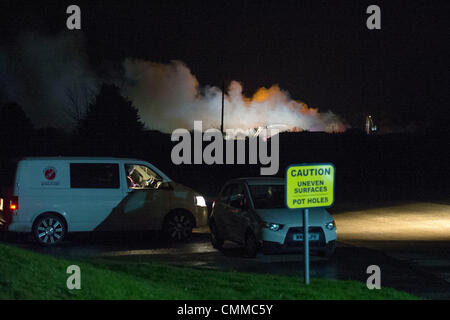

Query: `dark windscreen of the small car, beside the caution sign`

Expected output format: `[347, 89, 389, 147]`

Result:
[249, 184, 285, 209]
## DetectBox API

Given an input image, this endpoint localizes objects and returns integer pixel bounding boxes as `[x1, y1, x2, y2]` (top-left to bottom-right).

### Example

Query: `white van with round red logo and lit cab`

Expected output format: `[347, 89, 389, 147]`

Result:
[0, 157, 207, 245]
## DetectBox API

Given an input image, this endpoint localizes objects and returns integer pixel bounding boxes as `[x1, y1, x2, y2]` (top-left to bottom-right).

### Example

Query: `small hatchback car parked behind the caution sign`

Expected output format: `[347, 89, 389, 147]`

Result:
[209, 178, 337, 257]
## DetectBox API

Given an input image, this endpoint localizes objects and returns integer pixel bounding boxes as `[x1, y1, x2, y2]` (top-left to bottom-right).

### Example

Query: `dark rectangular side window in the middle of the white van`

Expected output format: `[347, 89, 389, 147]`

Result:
[70, 163, 120, 189]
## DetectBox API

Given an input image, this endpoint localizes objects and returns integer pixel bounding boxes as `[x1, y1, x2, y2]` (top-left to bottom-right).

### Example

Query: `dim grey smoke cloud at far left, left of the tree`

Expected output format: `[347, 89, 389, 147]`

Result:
[0, 33, 99, 129]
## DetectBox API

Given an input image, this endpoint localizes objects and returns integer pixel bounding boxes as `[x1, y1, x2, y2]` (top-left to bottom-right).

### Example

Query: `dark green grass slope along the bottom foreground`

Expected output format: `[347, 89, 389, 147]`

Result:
[0, 243, 418, 300]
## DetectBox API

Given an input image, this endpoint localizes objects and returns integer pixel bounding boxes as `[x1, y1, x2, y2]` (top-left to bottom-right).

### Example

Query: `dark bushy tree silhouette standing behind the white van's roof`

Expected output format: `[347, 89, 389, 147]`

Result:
[78, 84, 144, 155]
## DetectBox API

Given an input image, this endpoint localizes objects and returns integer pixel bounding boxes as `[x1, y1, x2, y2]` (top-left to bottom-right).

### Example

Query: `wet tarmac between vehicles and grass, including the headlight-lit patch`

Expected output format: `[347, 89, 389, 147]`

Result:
[1, 203, 450, 299]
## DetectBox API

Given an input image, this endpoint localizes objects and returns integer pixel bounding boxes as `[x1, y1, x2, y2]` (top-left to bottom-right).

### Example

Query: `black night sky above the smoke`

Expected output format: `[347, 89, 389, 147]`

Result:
[0, 0, 450, 128]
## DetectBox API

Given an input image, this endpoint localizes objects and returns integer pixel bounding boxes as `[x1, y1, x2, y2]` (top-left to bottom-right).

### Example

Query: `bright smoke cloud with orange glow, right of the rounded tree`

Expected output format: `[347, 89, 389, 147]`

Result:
[124, 59, 345, 132]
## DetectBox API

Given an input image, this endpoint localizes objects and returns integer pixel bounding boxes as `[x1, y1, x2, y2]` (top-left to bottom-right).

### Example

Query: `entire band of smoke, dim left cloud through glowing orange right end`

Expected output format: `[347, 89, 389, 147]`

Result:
[0, 32, 345, 132]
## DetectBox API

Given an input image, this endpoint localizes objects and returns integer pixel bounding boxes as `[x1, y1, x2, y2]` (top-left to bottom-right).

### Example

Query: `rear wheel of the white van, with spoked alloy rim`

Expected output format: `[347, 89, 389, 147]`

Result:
[33, 213, 67, 246]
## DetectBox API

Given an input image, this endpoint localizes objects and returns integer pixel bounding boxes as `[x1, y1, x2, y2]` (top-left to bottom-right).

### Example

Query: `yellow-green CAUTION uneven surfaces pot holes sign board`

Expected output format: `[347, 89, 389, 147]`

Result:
[286, 163, 335, 209]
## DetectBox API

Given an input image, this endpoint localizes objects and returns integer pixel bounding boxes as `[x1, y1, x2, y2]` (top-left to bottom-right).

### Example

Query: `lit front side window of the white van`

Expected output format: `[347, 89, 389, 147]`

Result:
[125, 164, 162, 189]
